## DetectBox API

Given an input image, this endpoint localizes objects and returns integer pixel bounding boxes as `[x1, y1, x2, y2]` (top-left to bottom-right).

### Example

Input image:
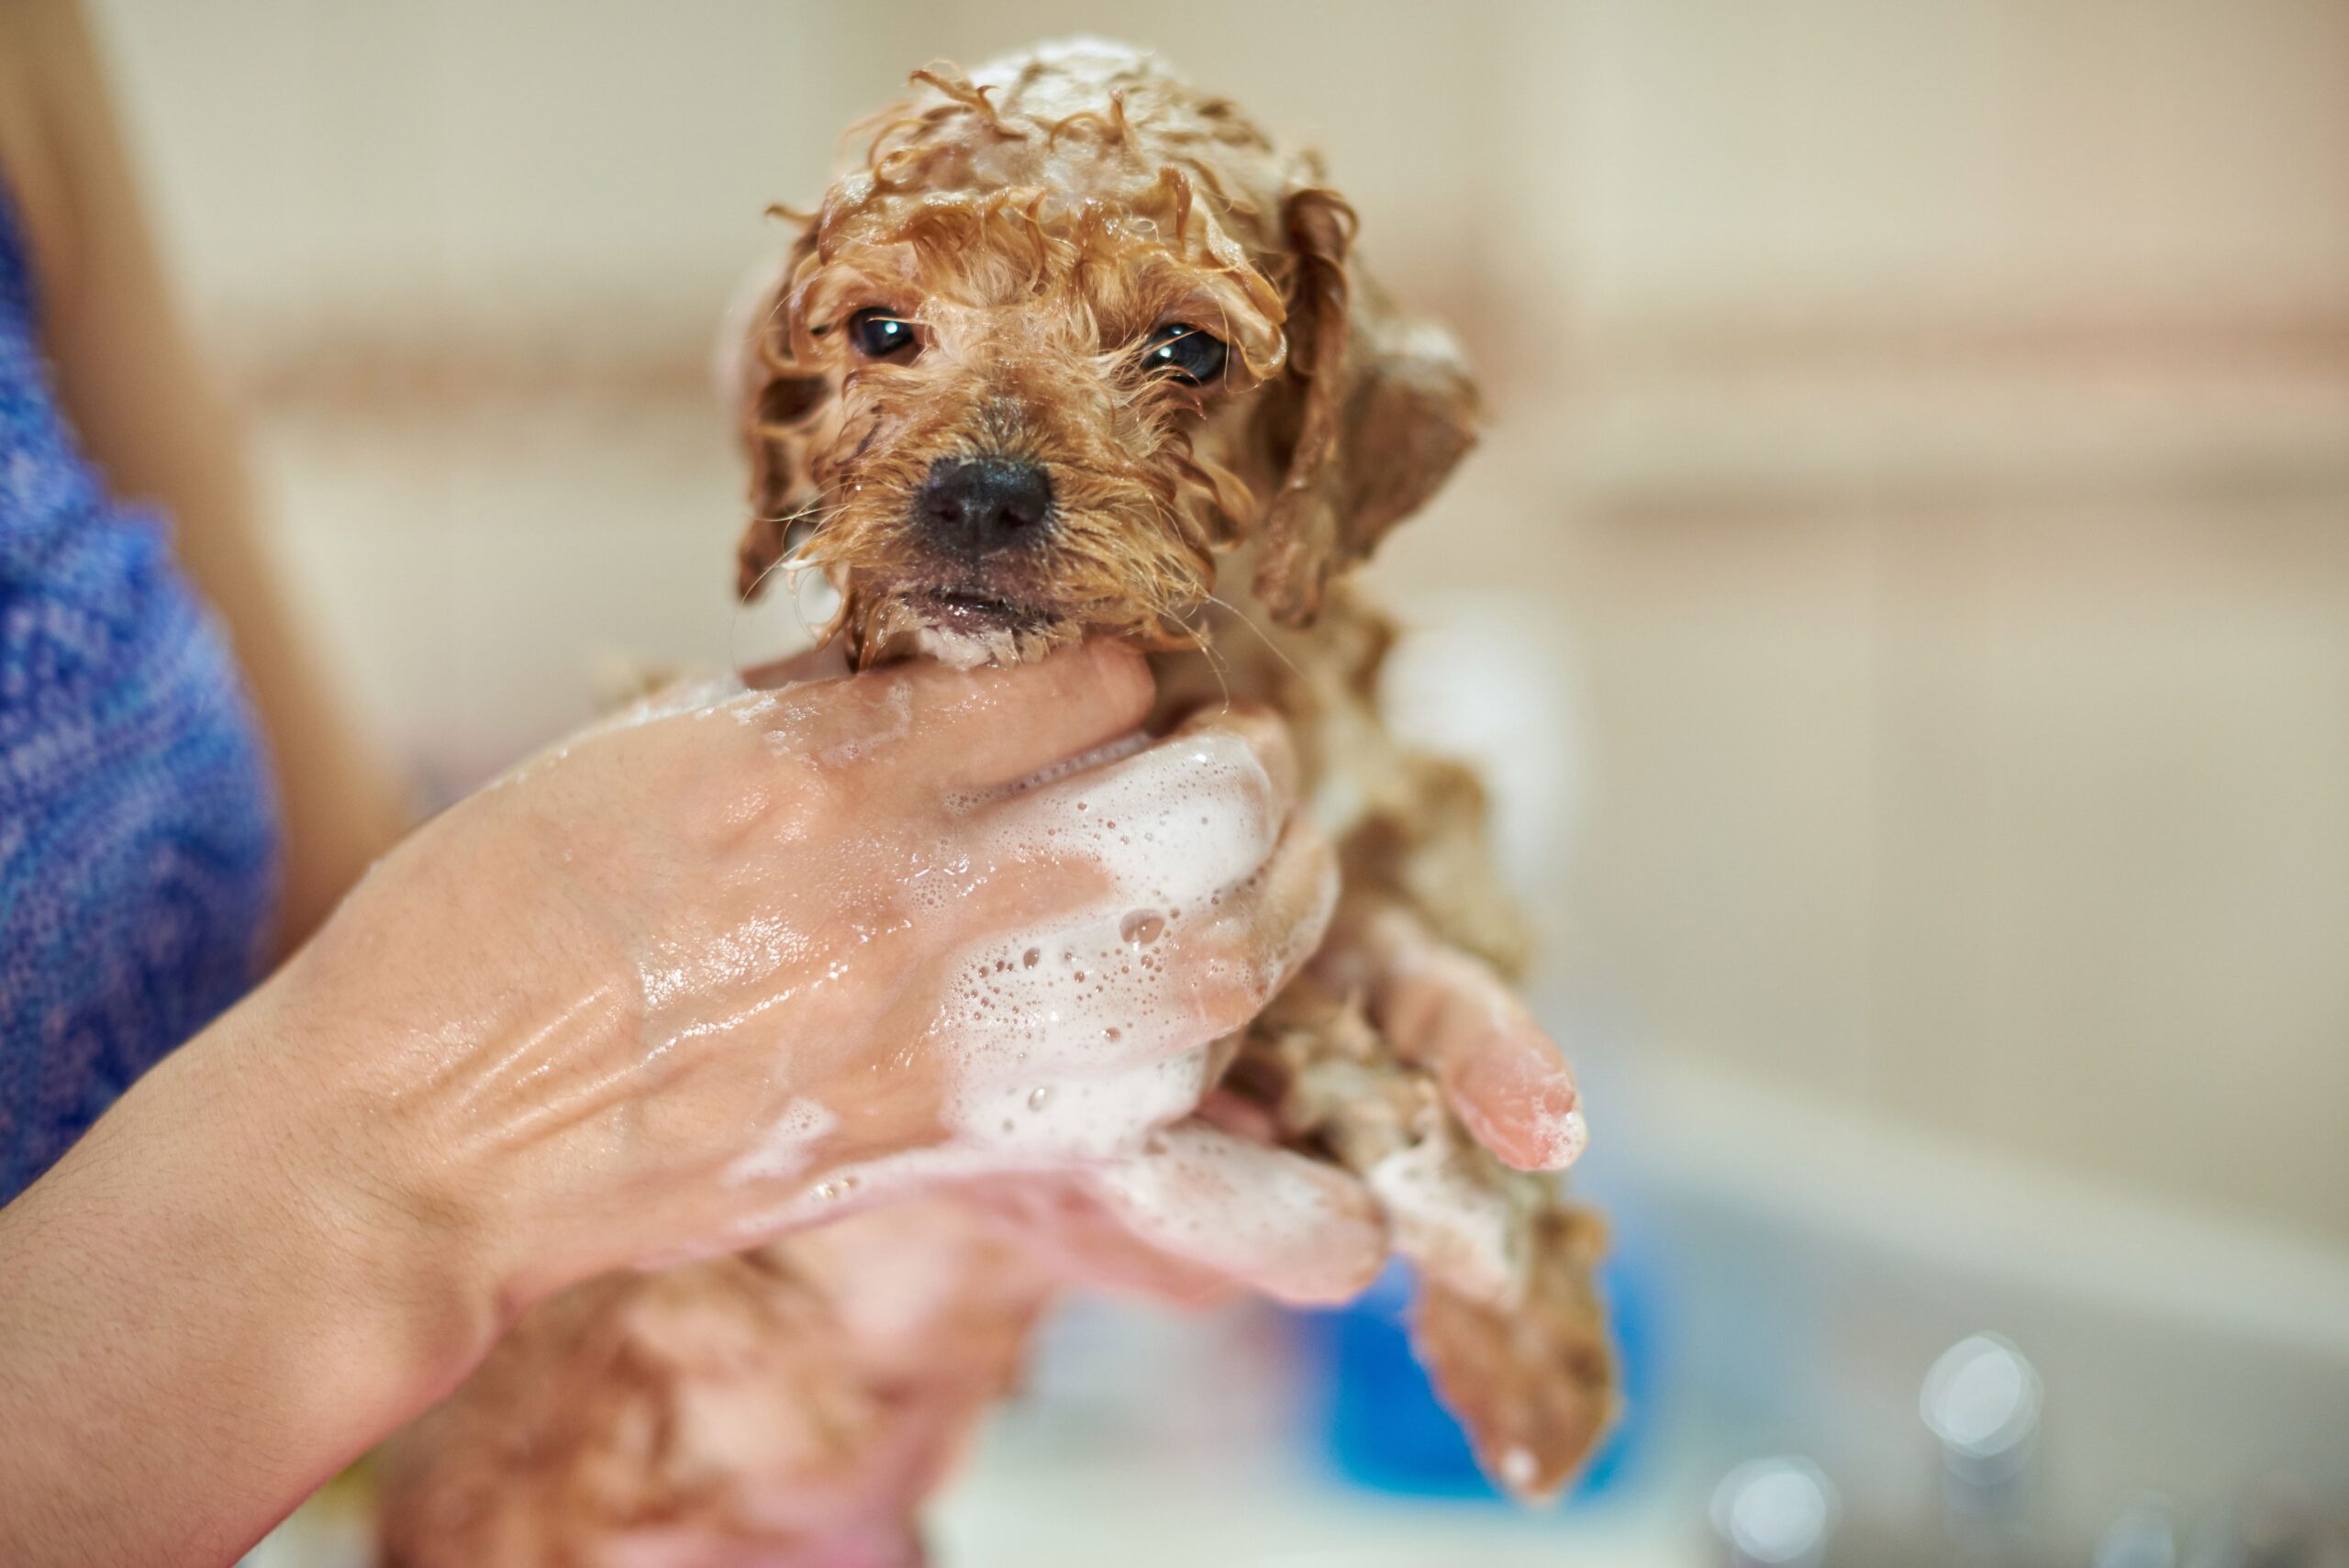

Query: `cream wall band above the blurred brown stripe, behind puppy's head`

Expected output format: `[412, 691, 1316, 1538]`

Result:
[96, 0, 2349, 351]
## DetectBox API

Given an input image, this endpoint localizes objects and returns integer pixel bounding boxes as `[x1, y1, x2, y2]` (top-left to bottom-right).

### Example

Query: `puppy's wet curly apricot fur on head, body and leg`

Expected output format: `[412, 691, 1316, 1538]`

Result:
[385, 39, 1614, 1568]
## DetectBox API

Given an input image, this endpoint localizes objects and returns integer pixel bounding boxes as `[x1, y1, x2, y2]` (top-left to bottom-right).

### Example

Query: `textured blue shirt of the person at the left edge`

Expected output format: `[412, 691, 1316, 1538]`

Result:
[0, 177, 277, 1202]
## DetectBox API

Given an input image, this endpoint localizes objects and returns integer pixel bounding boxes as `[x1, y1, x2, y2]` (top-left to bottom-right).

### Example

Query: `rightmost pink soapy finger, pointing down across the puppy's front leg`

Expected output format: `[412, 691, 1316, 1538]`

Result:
[1330, 911, 1588, 1172]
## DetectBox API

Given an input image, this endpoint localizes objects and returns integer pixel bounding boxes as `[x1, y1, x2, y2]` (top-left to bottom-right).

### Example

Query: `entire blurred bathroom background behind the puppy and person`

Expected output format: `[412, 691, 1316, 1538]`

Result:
[73, 0, 2349, 1568]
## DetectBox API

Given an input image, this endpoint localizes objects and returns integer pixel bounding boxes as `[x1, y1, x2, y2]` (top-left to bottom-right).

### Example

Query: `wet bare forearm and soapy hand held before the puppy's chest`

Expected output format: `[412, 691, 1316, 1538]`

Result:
[0, 648, 1384, 1568]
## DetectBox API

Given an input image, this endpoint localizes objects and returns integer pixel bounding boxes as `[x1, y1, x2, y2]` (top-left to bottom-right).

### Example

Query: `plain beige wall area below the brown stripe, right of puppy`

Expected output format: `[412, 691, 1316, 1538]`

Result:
[1503, 488, 2349, 1235]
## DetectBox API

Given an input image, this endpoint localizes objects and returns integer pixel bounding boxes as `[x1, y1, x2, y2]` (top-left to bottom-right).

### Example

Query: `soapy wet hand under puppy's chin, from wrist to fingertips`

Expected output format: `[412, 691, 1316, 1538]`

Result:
[251, 648, 1376, 1305]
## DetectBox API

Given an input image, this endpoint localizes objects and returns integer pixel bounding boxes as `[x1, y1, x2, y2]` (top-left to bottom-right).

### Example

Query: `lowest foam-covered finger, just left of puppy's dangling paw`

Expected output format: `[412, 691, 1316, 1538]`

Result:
[1090, 1122, 1386, 1303]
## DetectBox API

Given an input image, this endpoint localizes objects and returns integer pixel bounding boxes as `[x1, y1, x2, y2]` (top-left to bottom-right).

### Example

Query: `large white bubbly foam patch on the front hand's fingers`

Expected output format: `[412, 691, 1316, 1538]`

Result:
[714, 730, 1337, 1235]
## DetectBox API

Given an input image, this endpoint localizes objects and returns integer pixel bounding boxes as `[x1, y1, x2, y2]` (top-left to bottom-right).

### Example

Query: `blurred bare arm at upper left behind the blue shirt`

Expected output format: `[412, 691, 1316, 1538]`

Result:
[0, 0, 408, 946]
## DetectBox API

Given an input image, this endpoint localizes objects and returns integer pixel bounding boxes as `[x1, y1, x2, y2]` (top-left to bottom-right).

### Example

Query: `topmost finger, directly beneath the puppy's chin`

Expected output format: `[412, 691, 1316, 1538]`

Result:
[745, 639, 1156, 794]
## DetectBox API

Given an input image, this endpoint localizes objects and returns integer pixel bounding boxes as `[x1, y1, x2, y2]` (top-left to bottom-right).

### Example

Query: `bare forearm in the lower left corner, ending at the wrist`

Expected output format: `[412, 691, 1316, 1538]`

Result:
[0, 993, 495, 1568]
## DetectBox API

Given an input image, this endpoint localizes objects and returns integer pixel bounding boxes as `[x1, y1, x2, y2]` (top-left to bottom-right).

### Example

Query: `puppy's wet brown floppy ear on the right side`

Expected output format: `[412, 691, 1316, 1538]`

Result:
[1257, 185, 1477, 627]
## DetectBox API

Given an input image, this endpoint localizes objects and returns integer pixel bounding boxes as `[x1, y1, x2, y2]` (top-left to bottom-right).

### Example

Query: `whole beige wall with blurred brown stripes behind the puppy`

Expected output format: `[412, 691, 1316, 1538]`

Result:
[83, 0, 2349, 1241]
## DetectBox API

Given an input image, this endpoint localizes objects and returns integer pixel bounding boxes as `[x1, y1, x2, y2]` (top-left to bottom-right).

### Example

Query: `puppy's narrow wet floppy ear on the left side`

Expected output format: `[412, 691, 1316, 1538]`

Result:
[726, 230, 831, 598]
